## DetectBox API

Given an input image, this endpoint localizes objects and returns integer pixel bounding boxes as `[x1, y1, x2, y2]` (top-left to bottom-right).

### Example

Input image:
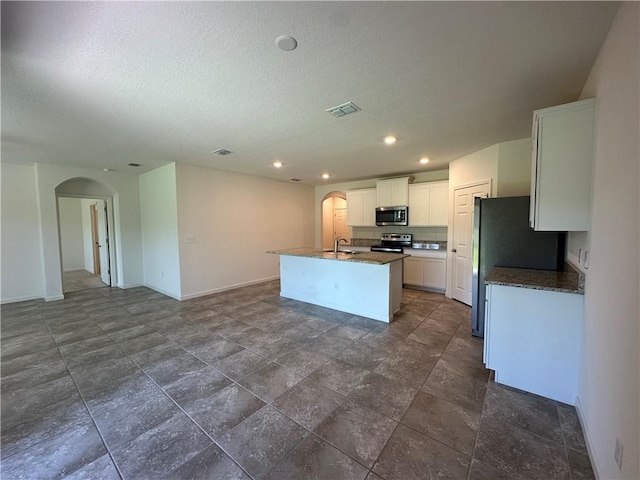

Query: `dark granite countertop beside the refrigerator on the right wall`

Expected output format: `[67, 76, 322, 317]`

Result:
[484, 267, 584, 295]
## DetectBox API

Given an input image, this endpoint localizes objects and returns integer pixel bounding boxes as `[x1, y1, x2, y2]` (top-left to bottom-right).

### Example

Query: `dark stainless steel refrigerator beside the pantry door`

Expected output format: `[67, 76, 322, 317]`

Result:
[471, 197, 566, 337]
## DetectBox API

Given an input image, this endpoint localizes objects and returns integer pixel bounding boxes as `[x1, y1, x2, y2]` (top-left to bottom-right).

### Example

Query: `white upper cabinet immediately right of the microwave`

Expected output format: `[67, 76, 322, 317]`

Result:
[409, 180, 449, 227]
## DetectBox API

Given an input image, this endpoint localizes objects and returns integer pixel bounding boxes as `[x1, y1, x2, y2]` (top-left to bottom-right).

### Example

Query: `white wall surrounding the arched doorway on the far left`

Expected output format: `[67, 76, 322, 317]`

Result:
[35, 163, 142, 301]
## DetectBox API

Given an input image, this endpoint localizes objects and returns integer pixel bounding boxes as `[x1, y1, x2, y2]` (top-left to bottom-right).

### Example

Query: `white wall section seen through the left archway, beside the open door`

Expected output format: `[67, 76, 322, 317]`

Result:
[58, 197, 84, 272]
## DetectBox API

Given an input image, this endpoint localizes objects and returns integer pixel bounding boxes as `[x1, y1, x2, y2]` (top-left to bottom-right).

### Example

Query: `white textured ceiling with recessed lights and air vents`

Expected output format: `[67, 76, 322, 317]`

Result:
[1, 1, 619, 185]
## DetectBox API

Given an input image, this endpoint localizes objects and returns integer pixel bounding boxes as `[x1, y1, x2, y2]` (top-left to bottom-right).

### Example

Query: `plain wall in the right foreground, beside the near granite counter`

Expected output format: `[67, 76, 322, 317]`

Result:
[578, 2, 640, 479]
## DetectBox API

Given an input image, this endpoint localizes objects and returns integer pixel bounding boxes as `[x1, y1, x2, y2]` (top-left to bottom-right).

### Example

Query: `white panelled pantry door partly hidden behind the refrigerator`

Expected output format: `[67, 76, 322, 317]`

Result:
[451, 181, 491, 305]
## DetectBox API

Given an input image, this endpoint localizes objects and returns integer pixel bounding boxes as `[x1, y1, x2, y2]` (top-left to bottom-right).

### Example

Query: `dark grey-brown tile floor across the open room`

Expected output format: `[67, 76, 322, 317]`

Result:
[1, 282, 593, 480]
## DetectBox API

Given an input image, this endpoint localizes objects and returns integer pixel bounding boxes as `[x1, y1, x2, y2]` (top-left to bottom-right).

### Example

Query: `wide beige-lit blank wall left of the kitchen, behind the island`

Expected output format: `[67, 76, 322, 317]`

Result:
[177, 164, 321, 298]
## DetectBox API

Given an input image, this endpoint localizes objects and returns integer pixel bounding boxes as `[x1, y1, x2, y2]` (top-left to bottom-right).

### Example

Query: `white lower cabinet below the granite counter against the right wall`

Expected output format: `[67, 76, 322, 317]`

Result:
[484, 285, 584, 405]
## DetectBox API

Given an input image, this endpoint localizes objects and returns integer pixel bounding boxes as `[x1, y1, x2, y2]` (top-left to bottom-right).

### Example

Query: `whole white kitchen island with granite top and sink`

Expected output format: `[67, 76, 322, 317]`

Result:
[267, 248, 408, 323]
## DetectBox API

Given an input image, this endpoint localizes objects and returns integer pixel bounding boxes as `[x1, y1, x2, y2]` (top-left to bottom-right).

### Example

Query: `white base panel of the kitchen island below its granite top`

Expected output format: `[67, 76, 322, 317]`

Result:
[280, 255, 402, 322]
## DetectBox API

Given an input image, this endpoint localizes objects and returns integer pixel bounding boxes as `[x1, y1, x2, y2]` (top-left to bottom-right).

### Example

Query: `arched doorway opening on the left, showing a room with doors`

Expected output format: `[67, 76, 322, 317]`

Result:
[55, 177, 116, 294]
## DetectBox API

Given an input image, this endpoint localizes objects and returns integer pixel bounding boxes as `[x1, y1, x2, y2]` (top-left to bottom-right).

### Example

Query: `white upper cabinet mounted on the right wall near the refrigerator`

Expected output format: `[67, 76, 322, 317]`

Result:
[529, 99, 595, 231]
